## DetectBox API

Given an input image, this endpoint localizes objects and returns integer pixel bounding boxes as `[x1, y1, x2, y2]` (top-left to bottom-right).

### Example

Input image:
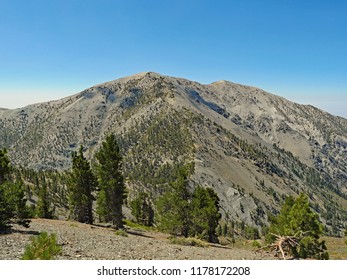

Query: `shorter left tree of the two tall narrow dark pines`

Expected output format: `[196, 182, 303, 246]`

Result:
[69, 146, 97, 224]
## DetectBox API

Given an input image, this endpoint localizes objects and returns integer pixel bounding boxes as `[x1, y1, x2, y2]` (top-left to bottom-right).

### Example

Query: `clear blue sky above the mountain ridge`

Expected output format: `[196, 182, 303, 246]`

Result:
[0, 0, 347, 117]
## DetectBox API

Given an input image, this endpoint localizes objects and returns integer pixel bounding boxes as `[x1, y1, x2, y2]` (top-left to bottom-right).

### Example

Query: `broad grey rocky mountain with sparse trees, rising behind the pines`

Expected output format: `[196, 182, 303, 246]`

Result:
[0, 72, 347, 234]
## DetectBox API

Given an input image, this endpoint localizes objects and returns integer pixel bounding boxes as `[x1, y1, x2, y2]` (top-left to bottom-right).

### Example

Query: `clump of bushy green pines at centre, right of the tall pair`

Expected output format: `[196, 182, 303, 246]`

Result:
[156, 168, 221, 242]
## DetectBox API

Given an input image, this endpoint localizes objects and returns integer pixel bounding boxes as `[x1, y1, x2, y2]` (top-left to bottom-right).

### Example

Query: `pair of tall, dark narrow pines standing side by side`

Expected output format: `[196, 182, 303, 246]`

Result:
[68, 134, 127, 229]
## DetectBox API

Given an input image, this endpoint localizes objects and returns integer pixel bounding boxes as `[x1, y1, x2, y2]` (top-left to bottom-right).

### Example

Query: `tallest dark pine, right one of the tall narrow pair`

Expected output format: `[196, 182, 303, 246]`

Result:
[95, 134, 127, 229]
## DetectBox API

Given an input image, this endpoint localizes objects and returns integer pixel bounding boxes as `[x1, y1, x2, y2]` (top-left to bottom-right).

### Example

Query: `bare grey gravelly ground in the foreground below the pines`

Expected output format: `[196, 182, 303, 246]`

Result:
[0, 219, 271, 260]
